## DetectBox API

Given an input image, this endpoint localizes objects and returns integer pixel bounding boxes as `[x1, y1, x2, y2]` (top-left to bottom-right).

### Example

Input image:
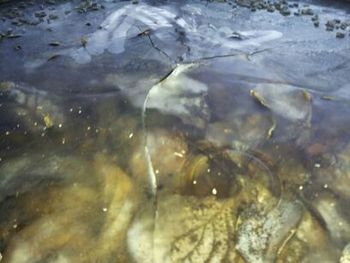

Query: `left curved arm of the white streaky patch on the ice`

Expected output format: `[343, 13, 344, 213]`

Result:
[63, 4, 187, 64]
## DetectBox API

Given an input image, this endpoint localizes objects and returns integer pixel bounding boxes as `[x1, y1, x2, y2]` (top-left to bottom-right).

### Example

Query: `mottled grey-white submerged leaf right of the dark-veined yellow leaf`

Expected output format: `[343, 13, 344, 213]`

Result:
[236, 200, 302, 262]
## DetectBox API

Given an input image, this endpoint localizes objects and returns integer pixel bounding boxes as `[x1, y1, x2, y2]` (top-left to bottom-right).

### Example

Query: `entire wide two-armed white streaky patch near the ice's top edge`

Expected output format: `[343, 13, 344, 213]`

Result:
[27, 4, 282, 68]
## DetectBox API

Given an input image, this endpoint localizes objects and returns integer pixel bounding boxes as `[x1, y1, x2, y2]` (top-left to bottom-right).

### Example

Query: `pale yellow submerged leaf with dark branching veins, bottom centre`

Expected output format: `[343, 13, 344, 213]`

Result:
[128, 196, 240, 263]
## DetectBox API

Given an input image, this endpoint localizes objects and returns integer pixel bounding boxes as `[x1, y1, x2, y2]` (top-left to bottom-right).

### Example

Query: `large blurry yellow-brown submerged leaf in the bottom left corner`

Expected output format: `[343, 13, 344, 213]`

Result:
[2, 155, 137, 263]
